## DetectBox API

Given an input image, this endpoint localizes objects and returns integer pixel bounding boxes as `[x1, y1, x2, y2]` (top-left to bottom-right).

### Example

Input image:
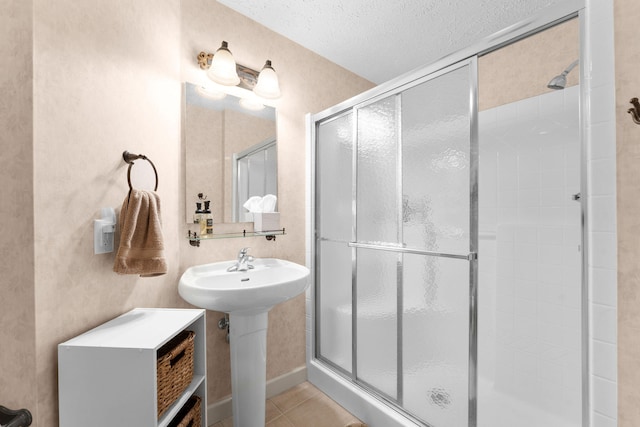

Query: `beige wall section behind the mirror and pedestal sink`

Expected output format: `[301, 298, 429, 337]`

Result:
[180, 0, 373, 402]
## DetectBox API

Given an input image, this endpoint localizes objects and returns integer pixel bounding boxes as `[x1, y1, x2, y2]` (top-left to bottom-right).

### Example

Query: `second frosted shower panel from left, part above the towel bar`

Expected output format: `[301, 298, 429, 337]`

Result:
[356, 95, 399, 244]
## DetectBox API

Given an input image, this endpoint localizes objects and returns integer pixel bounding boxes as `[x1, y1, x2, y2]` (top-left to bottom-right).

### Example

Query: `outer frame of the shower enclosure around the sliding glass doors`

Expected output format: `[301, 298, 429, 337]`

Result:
[306, 0, 590, 427]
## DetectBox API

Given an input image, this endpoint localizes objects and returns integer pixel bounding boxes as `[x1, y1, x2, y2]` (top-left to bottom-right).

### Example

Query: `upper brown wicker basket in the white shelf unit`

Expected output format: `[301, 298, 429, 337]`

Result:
[158, 331, 196, 418]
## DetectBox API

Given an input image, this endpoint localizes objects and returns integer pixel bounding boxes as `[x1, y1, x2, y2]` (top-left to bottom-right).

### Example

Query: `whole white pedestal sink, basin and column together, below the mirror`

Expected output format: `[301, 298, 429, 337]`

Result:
[178, 258, 309, 427]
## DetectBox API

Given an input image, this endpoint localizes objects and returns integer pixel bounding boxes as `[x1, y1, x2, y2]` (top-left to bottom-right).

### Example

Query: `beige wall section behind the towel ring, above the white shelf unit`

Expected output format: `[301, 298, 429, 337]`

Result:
[33, 0, 183, 427]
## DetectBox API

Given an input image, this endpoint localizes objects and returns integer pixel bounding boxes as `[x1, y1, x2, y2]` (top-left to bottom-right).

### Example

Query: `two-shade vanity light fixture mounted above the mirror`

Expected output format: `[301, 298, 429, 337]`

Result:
[198, 41, 280, 104]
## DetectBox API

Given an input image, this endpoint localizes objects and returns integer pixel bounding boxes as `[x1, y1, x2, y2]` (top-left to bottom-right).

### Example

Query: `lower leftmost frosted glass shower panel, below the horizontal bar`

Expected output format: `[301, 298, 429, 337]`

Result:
[316, 240, 352, 373]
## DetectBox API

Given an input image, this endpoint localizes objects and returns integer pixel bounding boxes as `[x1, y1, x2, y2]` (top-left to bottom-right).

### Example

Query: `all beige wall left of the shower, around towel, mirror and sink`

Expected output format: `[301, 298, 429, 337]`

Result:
[0, 0, 371, 427]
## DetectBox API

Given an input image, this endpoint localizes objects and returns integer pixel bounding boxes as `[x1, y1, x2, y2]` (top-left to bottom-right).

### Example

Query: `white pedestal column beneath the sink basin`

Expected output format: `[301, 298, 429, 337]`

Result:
[229, 312, 267, 427]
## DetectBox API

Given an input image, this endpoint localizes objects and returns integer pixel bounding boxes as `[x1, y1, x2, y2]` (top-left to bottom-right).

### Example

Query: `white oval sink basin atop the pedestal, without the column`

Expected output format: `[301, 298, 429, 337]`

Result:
[178, 258, 309, 314]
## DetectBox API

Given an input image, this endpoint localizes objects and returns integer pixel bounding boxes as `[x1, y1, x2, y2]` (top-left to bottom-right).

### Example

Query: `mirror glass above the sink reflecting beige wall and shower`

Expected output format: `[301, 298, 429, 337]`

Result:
[184, 83, 278, 224]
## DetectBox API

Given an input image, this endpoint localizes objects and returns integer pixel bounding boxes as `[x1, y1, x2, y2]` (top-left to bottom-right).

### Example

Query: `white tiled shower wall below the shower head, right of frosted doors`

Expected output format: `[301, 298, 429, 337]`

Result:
[479, 86, 581, 426]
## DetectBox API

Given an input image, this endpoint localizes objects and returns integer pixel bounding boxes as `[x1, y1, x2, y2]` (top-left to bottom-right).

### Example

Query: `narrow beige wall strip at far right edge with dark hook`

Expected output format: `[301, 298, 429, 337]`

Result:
[614, 0, 640, 427]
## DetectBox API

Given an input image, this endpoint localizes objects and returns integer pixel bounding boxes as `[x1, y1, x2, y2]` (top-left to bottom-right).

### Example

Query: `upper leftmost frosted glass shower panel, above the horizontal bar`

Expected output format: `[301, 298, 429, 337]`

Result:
[316, 113, 353, 241]
